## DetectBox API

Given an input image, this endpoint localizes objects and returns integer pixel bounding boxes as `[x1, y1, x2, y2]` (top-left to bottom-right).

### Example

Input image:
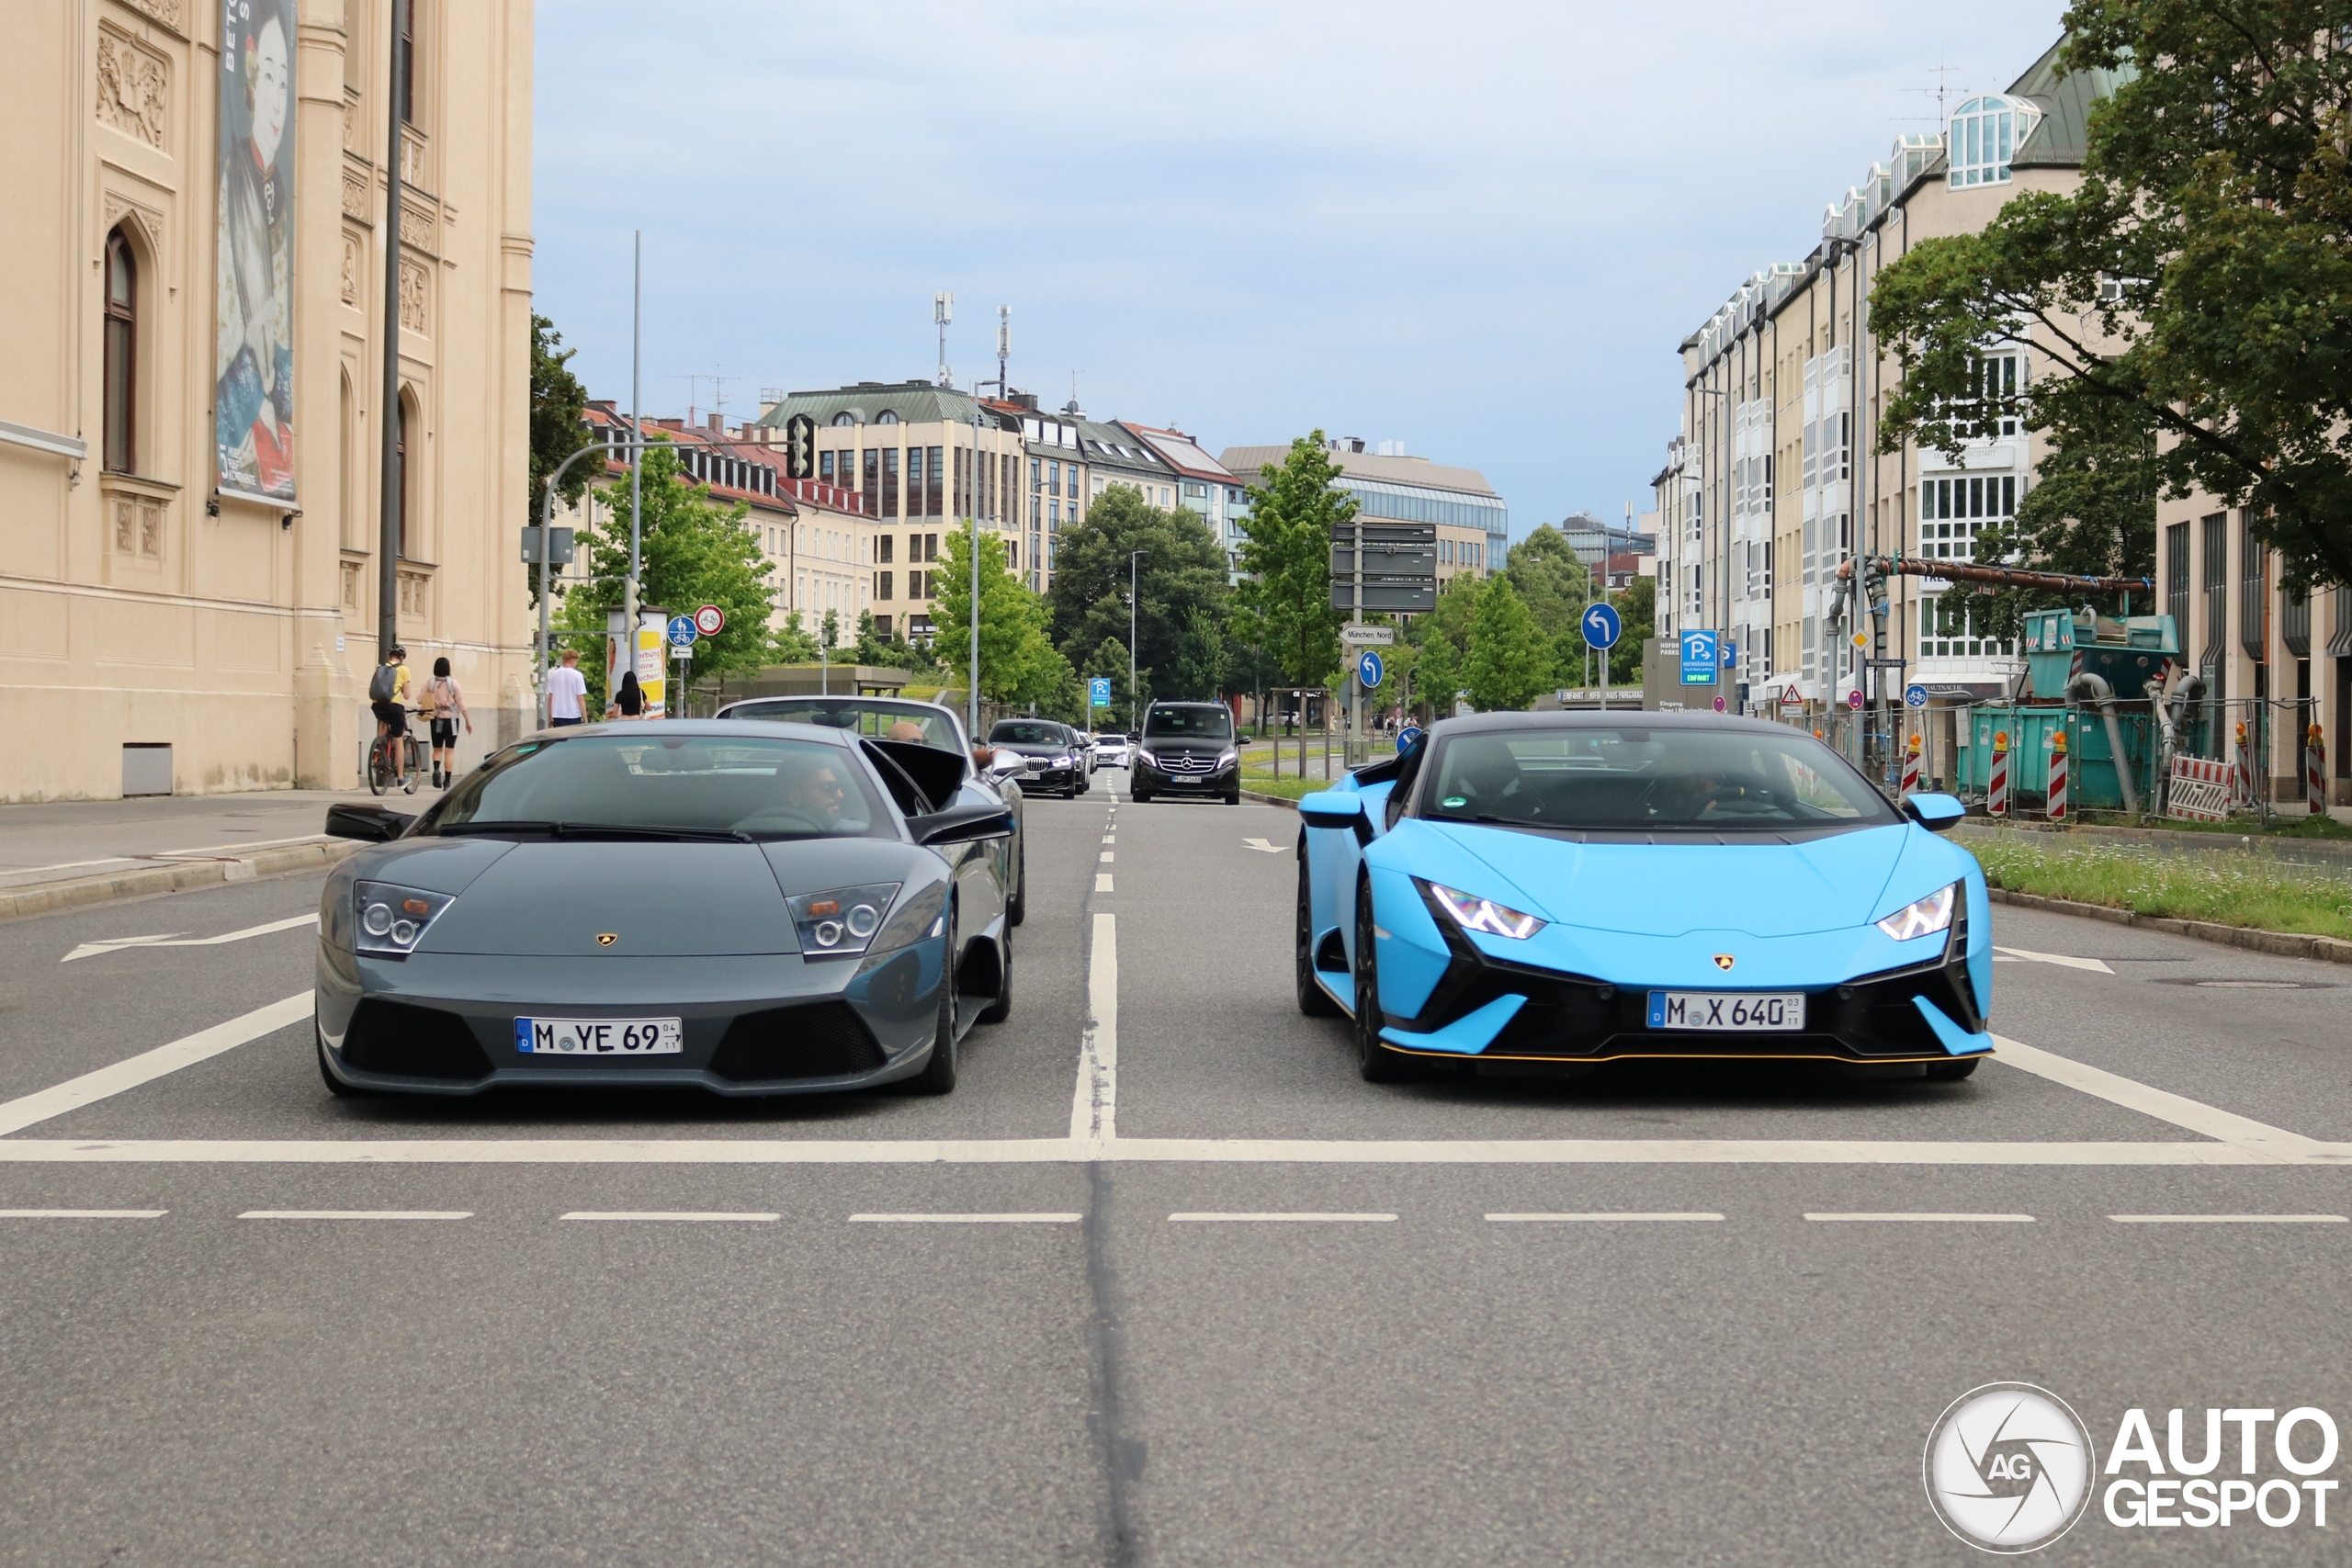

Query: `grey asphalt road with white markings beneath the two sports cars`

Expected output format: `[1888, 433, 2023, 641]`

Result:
[0, 773, 2352, 1568]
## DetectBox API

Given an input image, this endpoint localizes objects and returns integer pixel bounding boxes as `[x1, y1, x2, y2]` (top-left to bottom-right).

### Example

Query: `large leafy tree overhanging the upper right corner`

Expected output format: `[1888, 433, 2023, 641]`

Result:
[1872, 0, 2352, 585]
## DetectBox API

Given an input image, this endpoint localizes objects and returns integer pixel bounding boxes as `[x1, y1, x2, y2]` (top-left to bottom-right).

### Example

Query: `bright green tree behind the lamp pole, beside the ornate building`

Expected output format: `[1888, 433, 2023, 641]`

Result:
[560, 442, 776, 680]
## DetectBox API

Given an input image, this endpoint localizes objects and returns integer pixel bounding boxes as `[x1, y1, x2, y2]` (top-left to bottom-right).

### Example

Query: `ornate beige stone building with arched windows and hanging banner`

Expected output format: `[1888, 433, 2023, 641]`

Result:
[0, 0, 532, 799]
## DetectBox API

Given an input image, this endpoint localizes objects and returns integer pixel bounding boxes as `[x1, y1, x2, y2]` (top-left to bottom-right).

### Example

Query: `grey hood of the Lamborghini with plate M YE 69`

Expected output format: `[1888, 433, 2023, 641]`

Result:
[419, 841, 795, 959]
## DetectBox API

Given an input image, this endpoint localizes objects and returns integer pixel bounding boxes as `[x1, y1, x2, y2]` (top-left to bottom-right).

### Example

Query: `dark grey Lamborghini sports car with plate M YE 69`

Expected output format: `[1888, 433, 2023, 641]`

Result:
[318, 719, 1013, 1096]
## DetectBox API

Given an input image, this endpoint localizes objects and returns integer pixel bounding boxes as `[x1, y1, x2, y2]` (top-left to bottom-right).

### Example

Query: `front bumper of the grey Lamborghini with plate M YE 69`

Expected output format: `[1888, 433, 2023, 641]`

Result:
[318, 938, 945, 1096]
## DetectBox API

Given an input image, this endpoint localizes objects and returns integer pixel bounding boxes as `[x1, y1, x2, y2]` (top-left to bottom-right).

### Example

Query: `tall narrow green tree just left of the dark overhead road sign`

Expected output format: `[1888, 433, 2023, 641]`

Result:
[1235, 430, 1355, 686]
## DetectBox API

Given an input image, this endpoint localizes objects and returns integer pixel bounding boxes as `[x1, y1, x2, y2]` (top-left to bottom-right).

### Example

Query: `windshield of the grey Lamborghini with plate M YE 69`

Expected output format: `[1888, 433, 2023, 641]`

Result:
[424, 724, 896, 840]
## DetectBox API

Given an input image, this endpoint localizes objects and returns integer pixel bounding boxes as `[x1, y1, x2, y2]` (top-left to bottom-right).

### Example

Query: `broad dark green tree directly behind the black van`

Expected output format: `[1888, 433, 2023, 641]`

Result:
[1046, 484, 1227, 698]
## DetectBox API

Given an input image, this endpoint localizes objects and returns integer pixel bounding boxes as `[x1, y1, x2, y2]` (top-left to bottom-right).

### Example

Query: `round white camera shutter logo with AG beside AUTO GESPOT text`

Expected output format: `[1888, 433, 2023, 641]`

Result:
[1922, 1382, 2098, 1554]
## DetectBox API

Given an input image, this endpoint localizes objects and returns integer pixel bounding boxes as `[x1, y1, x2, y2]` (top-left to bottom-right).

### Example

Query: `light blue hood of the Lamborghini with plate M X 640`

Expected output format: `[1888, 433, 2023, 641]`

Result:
[1425, 823, 1928, 936]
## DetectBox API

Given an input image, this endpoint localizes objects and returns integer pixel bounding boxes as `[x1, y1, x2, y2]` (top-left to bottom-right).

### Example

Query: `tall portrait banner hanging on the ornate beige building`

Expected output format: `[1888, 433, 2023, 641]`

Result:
[211, 0, 297, 503]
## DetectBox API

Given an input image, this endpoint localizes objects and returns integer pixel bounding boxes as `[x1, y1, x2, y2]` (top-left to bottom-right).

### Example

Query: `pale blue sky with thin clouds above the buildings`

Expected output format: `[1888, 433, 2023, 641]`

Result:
[534, 0, 2061, 536]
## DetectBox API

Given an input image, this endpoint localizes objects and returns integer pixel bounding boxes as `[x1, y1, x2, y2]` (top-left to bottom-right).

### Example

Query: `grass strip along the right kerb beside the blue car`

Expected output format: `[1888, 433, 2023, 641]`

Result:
[1969, 841, 2352, 938]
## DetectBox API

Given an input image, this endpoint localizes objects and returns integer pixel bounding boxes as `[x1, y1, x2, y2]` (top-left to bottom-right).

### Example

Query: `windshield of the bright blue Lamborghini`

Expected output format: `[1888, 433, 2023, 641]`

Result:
[1420, 724, 1900, 832]
